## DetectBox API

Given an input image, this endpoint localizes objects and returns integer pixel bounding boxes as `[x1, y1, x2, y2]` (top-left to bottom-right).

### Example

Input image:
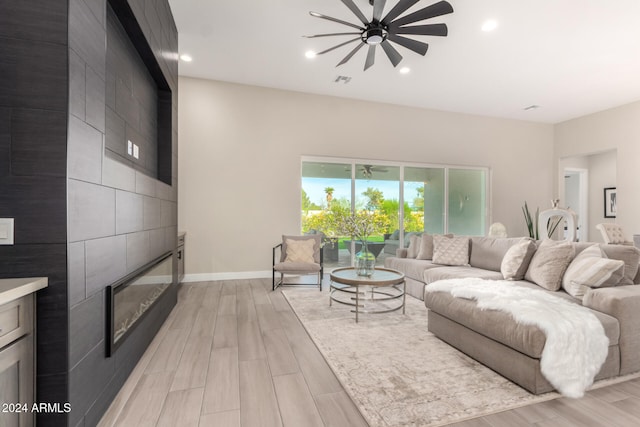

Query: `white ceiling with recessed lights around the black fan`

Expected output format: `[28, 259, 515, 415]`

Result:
[169, 0, 640, 123]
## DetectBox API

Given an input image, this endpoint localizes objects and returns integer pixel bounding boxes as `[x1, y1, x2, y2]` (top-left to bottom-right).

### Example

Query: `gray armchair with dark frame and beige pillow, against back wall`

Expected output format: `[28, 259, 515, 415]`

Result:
[273, 234, 324, 291]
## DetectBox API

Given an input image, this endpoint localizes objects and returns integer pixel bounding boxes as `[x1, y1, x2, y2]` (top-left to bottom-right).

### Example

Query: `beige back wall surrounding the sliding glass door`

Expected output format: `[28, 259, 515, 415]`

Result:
[178, 78, 556, 280]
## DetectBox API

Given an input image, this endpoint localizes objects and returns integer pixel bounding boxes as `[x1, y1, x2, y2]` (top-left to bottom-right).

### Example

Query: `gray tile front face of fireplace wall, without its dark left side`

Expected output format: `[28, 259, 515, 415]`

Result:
[67, 0, 178, 426]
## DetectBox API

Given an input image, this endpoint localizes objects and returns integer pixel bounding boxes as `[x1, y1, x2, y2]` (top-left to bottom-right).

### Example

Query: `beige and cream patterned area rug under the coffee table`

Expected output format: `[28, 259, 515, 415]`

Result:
[282, 288, 559, 427]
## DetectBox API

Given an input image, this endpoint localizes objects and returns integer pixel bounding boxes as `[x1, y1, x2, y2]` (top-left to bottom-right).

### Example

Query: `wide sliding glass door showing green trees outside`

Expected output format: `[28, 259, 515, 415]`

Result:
[301, 159, 488, 268]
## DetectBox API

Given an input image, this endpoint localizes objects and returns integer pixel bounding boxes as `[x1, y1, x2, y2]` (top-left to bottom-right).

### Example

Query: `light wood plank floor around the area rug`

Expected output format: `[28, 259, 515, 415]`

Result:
[99, 279, 640, 427]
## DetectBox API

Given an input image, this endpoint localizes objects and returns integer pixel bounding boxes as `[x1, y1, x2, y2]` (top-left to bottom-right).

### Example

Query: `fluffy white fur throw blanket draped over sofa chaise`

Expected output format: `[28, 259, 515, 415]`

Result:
[426, 278, 609, 398]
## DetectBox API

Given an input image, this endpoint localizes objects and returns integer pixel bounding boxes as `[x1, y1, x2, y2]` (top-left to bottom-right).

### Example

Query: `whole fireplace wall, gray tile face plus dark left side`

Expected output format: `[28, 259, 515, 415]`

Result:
[0, 0, 178, 427]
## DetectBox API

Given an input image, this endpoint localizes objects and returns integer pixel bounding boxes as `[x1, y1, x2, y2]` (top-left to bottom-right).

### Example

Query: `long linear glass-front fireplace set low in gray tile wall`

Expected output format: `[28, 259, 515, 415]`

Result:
[107, 252, 174, 357]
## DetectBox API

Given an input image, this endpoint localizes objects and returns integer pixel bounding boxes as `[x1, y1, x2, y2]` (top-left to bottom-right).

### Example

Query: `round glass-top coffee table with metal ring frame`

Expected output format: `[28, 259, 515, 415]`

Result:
[329, 267, 406, 323]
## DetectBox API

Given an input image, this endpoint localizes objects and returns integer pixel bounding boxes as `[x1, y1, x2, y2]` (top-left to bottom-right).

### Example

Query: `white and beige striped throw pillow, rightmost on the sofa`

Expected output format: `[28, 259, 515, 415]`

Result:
[562, 244, 624, 299]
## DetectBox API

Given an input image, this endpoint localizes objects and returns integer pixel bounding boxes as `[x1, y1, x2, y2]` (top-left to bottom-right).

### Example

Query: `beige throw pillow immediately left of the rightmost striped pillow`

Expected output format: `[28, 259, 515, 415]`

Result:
[524, 239, 575, 291]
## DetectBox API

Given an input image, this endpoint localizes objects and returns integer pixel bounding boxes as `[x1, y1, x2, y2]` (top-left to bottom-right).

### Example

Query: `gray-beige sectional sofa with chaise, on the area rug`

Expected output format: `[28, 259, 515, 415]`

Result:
[385, 237, 640, 394]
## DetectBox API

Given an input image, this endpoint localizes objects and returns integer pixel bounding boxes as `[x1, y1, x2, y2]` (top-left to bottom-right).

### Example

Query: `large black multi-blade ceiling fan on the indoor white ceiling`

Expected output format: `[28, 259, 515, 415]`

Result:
[304, 0, 453, 71]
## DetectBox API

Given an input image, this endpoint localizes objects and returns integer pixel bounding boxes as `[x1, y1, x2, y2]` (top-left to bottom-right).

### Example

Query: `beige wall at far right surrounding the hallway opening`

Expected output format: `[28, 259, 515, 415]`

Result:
[554, 102, 640, 241]
